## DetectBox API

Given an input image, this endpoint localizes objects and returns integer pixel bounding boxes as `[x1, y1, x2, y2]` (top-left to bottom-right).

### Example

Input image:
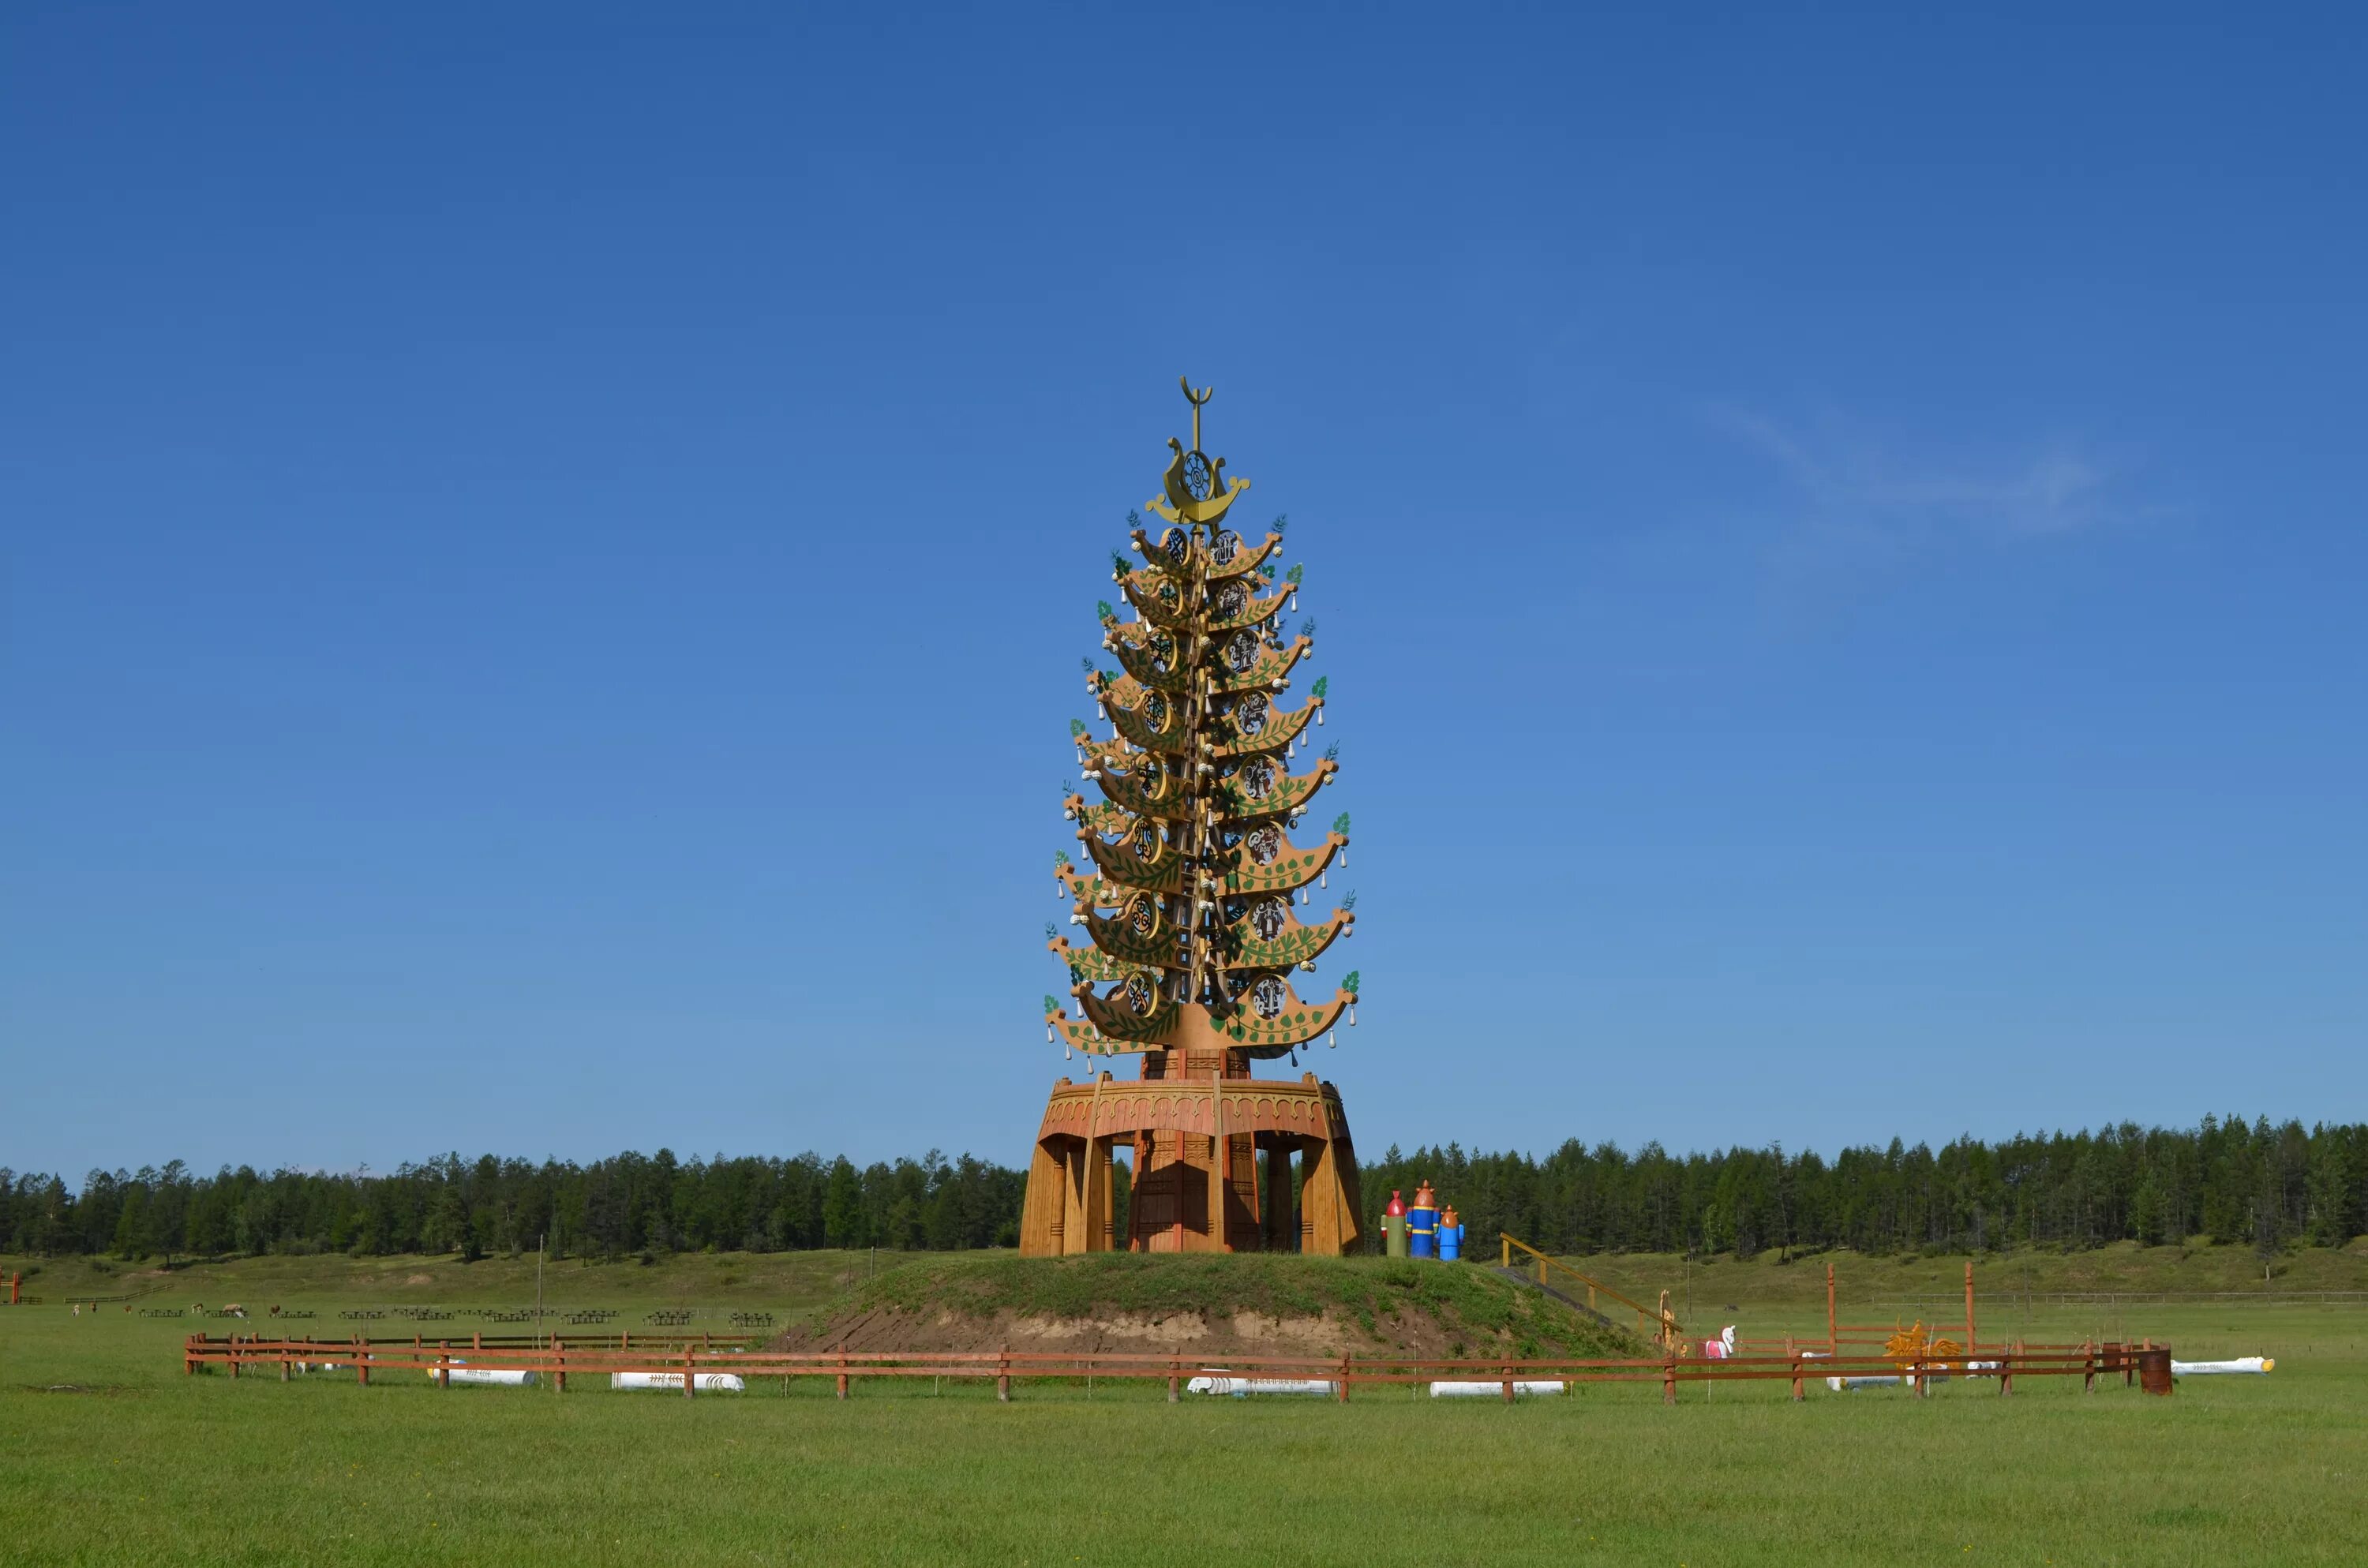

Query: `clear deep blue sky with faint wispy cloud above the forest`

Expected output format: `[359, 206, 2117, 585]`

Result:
[0, 5, 2368, 1173]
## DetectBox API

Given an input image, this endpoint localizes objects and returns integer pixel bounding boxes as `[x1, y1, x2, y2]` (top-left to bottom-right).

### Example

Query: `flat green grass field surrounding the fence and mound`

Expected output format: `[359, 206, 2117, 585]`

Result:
[0, 1248, 2368, 1568]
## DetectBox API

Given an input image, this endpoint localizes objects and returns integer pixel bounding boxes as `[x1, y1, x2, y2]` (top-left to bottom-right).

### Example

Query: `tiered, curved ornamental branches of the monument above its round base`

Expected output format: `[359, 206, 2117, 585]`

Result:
[1044, 440, 1357, 1057]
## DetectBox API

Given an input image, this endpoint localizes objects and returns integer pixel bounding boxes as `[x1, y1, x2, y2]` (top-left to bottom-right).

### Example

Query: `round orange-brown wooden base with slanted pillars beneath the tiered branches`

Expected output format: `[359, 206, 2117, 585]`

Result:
[1021, 1052, 1359, 1258]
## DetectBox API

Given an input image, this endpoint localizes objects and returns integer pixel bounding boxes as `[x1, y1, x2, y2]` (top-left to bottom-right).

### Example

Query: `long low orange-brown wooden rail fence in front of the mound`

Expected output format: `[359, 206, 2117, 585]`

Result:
[182, 1334, 2171, 1402]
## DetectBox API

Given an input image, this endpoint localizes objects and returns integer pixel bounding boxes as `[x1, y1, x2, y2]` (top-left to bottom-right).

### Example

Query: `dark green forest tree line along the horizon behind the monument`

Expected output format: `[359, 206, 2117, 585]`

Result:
[0, 1116, 2368, 1260]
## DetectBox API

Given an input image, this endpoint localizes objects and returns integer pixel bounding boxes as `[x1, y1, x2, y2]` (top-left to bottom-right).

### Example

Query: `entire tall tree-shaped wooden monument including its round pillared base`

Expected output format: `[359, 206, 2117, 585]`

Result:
[1021, 381, 1357, 1256]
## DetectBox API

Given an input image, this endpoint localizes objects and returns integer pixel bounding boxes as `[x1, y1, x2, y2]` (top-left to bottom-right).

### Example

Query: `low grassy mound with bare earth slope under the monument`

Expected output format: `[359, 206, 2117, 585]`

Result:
[800, 1253, 1639, 1355]
